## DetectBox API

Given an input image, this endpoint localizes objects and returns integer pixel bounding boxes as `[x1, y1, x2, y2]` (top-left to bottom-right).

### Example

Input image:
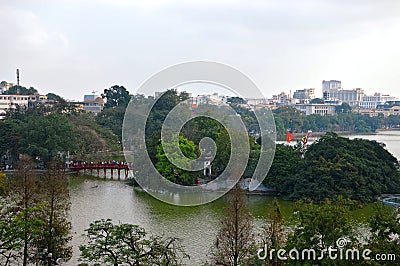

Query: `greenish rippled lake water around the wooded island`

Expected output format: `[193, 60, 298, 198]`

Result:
[67, 131, 400, 265]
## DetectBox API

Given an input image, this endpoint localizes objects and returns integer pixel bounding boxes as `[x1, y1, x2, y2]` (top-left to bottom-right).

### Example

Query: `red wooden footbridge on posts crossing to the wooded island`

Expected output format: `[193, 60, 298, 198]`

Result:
[67, 161, 129, 179]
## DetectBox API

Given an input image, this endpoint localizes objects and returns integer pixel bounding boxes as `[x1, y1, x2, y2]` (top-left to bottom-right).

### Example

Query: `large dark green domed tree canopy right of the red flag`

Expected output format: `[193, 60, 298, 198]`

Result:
[264, 133, 400, 202]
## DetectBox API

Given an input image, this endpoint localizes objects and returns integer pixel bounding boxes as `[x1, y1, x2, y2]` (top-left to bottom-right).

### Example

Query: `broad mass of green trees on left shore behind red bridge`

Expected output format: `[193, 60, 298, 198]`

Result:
[0, 103, 120, 165]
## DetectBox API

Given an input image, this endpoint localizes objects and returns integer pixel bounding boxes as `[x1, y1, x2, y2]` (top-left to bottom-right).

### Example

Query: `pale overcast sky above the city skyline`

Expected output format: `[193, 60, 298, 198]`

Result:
[0, 0, 400, 100]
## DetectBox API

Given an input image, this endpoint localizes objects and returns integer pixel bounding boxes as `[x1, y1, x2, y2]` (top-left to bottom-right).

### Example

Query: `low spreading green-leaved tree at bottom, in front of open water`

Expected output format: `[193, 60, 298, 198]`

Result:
[79, 219, 188, 265]
